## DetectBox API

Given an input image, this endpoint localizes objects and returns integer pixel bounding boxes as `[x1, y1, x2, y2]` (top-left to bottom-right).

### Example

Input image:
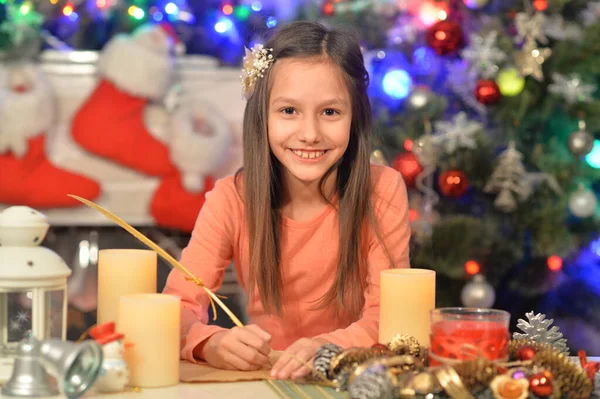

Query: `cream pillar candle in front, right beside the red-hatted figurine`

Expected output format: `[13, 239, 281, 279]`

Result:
[117, 294, 181, 388]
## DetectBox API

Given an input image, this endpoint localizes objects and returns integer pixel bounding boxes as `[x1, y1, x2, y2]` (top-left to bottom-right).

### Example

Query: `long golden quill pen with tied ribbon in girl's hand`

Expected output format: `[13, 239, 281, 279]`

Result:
[68, 194, 244, 327]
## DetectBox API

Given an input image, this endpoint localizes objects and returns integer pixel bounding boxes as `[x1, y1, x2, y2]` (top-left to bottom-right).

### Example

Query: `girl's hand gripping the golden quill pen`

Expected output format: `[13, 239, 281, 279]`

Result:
[202, 325, 271, 371]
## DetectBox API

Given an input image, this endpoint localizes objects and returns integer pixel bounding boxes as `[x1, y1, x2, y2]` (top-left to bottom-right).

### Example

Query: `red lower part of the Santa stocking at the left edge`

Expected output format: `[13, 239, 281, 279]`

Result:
[0, 134, 100, 208]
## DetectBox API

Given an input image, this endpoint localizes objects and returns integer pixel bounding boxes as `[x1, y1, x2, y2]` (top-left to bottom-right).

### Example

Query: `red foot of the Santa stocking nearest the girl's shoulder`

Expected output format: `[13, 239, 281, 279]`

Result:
[150, 172, 214, 233]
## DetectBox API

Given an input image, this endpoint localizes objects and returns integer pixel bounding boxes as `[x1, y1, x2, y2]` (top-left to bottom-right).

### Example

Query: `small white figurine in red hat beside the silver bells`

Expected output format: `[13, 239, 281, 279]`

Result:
[90, 322, 129, 393]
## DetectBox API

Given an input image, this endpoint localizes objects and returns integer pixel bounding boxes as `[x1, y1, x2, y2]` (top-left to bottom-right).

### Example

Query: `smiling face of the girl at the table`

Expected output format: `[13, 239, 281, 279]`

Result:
[268, 58, 352, 188]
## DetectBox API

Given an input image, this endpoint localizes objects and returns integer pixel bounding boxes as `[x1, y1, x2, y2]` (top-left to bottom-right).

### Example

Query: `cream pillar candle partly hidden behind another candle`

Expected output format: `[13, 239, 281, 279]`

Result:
[98, 249, 157, 324]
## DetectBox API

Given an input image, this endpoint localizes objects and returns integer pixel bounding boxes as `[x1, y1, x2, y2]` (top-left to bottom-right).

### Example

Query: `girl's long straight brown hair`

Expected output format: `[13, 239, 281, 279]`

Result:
[236, 21, 391, 314]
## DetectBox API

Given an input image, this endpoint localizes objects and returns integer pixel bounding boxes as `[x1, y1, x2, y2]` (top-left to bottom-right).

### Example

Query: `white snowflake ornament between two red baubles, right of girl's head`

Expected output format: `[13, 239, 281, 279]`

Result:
[432, 112, 483, 154]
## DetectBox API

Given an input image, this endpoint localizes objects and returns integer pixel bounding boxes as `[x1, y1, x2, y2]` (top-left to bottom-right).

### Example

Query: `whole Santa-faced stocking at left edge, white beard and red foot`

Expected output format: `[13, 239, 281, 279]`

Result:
[0, 63, 100, 208]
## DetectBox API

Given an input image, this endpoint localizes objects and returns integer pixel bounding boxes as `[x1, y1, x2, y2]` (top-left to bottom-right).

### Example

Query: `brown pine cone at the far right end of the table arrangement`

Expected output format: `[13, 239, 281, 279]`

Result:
[532, 349, 594, 399]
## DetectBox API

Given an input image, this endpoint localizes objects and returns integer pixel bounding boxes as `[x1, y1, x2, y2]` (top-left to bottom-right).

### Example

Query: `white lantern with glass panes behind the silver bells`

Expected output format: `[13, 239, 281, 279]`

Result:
[0, 206, 71, 381]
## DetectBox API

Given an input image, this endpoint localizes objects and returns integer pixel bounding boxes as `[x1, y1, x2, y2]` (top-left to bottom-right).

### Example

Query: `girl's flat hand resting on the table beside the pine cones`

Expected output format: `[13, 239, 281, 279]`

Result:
[271, 338, 329, 380]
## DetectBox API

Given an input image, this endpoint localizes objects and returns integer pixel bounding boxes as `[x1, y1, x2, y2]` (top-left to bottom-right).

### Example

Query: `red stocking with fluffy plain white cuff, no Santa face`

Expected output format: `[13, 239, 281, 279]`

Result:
[72, 25, 175, 176]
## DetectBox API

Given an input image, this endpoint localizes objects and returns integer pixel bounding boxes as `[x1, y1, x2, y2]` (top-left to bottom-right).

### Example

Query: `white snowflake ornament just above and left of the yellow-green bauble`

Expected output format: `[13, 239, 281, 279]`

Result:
[460, 31, 506, 79]
